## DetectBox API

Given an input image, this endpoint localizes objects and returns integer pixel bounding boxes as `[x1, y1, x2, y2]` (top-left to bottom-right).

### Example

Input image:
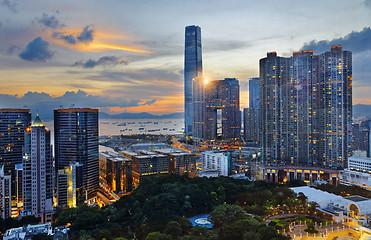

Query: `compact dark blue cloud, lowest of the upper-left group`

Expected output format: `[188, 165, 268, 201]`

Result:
[19, 37, 53, 62]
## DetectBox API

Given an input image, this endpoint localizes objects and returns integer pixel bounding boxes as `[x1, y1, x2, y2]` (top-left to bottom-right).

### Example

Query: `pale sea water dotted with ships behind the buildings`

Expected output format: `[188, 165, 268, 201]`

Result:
[43, 118, 184, 138]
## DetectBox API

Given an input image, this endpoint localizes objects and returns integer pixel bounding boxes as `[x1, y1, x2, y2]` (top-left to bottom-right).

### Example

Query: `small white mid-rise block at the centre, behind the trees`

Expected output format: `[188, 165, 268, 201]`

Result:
[200, 151, 231, 177]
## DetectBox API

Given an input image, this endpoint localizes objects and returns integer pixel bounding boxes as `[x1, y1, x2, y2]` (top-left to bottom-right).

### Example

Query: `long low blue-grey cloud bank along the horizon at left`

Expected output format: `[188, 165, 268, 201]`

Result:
[0, 90, 156, 119]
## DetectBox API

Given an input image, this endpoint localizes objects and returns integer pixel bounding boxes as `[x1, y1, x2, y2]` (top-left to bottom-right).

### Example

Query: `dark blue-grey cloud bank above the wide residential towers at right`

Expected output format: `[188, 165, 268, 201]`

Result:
[301, 27, 371, 53]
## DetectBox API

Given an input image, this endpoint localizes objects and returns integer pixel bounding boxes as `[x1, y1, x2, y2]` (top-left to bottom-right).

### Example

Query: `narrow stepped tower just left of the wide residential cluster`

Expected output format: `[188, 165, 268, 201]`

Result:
[243, 78, 260, 143]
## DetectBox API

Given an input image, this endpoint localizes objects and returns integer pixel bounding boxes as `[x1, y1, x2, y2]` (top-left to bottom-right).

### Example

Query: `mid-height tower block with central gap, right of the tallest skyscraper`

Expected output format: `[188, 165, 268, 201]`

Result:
[203, 78, 241, 140]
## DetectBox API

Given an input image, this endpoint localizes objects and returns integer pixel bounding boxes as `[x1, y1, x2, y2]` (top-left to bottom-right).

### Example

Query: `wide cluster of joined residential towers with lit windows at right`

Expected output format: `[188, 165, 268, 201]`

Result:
[260, 46, 352, 181]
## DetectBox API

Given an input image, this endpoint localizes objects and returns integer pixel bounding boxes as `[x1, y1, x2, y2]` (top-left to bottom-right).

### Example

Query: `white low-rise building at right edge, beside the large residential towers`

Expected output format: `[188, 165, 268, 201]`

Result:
[339, 156, 371, 191]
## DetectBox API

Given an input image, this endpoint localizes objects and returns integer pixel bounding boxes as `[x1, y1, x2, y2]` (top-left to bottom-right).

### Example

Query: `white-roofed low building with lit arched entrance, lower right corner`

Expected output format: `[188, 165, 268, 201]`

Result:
[291, 186, 371, 229]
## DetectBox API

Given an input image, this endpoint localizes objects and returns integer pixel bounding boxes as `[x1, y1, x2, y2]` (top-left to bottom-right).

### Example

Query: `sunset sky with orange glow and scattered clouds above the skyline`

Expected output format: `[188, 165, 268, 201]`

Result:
[0, 0, 371, 116]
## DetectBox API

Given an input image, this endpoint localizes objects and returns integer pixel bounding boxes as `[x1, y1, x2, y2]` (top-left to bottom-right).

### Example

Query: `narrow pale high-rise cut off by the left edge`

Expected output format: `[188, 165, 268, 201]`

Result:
[0, 165, 12, 219]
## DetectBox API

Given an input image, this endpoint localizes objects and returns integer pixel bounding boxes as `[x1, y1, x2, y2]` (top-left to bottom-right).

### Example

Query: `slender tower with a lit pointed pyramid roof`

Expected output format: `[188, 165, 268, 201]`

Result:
[22, 115, 54, 221]
